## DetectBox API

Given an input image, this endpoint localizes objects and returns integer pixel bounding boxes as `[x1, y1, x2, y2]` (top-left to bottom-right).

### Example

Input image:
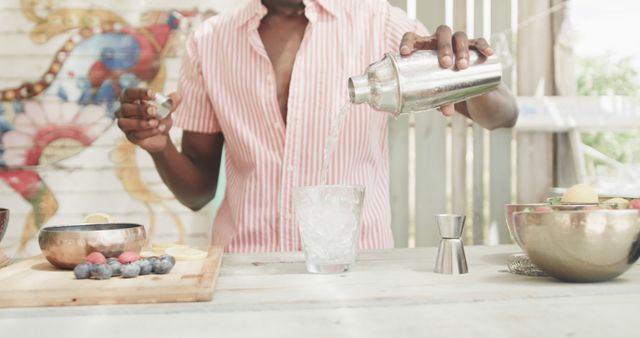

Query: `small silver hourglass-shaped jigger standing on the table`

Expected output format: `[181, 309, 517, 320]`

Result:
[435, 214, 469, 275]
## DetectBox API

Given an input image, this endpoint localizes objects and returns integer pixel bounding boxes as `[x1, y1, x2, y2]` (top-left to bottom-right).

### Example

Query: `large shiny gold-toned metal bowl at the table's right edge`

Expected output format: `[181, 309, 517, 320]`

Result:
[513, 209, 640, 282]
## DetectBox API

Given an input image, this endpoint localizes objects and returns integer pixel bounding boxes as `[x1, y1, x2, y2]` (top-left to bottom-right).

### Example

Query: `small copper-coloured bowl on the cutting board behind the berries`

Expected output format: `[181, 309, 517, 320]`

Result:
[38, 223, 147, 269]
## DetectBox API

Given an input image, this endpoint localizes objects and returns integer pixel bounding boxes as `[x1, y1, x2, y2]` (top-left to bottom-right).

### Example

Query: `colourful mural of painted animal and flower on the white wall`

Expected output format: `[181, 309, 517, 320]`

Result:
[0, 0, 229, 252]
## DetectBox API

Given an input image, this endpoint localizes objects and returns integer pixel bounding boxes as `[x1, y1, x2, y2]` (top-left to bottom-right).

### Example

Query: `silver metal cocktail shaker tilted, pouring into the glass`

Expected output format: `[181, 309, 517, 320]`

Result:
[349, 50, 502, 116]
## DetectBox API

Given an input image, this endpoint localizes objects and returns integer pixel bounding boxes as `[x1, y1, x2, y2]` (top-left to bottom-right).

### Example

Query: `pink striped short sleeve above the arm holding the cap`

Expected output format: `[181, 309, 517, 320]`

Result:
[174, 35, 221, 133]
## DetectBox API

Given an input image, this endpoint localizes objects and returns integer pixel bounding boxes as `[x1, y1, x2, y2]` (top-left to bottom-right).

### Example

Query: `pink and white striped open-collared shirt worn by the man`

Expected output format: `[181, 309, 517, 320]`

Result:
[175, 0, 426, 252]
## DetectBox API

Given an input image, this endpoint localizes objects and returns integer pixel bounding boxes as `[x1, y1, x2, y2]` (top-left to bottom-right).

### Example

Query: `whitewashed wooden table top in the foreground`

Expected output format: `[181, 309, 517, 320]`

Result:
[0, 246, 640, 338]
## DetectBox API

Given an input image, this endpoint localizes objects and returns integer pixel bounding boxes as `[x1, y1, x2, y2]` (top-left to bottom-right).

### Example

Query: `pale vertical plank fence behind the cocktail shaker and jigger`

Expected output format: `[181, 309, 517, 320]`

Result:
[389, 0, 514, 247]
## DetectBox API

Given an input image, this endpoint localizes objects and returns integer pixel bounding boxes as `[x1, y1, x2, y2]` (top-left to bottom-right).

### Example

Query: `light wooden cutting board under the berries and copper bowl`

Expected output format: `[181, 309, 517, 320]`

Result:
[0, 247, 223, 308]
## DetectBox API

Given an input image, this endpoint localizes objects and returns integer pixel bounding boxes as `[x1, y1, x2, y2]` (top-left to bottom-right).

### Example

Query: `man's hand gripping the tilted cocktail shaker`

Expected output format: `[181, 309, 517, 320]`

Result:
[400, 25, 493, 116]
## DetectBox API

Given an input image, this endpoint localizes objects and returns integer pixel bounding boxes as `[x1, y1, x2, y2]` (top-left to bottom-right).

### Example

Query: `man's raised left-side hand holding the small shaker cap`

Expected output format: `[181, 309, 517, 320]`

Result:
[116, 88, 180, 153]
